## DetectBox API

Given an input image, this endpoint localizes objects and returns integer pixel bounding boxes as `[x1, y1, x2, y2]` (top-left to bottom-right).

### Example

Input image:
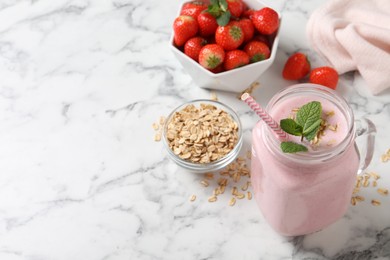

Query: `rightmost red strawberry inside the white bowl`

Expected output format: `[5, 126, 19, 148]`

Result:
[252, 7, 279, 35]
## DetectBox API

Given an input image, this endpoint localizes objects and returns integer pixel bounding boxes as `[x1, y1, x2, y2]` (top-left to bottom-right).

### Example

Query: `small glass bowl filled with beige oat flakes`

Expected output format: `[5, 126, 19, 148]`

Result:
[163, 99, 242, 172]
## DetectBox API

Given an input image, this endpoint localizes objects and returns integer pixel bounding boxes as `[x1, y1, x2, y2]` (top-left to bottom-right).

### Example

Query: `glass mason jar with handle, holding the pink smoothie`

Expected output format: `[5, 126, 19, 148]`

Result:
[251, 84, 376, 236]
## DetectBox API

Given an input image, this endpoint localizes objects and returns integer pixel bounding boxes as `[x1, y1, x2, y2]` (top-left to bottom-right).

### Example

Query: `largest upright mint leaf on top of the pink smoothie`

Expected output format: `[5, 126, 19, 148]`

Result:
[297, 101, 322, 133]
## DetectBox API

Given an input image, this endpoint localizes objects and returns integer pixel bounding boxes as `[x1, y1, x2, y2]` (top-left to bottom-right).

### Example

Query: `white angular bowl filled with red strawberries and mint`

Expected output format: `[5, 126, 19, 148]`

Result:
[170, 0, 281, 92]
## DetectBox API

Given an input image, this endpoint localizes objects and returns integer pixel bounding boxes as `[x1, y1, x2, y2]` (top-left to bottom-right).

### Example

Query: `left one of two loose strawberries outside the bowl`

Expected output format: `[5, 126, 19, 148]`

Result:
[282, 52, 310, 80]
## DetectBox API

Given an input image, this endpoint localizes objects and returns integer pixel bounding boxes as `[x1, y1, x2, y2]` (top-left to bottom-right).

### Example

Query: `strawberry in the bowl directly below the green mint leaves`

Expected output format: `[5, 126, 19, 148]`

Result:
[215, 21, 244, 51]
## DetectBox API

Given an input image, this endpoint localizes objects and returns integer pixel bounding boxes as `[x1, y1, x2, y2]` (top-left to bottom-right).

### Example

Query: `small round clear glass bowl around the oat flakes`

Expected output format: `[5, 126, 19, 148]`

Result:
[162, 99, 243, 173]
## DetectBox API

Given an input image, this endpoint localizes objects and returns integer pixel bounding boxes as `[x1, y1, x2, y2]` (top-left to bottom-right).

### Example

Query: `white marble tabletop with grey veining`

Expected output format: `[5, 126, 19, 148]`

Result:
[0, 0, 390, 260]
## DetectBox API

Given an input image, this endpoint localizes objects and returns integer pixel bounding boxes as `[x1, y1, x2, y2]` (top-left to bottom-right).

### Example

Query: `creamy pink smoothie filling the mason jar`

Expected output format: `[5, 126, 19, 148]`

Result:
[251, 96, 359, 236]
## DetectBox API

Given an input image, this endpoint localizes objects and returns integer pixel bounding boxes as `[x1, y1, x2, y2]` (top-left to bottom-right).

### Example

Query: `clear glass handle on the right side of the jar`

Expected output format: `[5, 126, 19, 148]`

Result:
[355, 118, 376, 174]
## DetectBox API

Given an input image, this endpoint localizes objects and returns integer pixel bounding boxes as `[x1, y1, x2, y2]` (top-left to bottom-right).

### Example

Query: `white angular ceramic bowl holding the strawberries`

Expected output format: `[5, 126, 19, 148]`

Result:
[170, 0, 281, 93]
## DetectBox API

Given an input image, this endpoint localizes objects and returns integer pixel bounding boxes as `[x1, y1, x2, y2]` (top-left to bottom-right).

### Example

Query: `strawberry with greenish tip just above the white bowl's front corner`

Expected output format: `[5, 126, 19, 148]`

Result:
[199, 44, 225, 70]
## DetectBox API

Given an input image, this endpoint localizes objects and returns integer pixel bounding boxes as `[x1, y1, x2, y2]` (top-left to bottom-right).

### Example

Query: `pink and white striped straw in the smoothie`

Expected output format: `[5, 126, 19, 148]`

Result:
[241, 93, 288, 141]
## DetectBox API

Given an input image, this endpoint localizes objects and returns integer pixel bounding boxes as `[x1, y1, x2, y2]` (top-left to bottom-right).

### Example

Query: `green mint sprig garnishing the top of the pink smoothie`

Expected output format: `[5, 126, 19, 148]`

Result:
[280, 101, 322, 153]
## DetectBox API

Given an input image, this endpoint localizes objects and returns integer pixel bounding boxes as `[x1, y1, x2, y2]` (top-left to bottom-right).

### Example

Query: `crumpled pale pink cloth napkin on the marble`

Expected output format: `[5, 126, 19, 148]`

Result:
[306, 0, 390, 95]
